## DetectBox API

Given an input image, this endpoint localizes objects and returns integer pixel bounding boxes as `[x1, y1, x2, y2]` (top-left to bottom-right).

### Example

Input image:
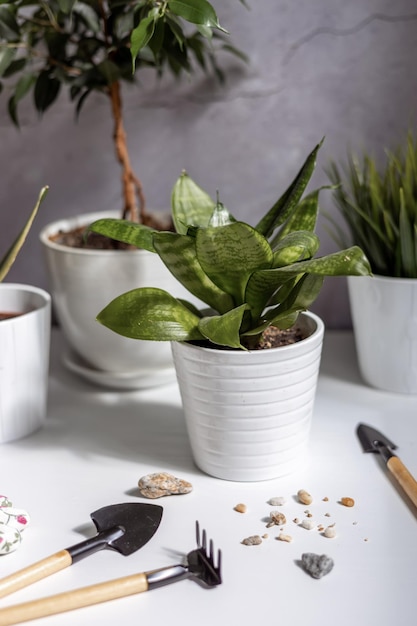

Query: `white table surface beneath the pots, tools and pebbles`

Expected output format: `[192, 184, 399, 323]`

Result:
[0, 331, 417, 626]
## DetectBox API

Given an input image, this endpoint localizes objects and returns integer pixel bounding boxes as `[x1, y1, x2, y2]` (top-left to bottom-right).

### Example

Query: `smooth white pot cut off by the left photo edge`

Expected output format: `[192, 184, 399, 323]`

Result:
[0, 283, 51, 443]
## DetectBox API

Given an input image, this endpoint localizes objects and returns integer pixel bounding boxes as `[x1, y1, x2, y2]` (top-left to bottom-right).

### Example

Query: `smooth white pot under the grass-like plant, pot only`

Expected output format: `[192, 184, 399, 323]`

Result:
[348, 276, 417, 394]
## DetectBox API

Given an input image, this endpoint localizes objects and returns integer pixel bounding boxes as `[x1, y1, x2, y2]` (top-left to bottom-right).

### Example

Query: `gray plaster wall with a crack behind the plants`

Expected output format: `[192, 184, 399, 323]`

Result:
[0, 0, 417, 328]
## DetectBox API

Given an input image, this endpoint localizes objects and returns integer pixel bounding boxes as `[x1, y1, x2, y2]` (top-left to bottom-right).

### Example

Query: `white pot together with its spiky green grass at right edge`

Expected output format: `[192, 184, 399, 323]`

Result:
[329, 132, 417, 394]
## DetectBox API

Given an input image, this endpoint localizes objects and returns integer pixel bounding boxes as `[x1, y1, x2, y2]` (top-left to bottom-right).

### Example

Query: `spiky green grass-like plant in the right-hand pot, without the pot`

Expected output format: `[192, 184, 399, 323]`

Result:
[328, 132, 417, 278]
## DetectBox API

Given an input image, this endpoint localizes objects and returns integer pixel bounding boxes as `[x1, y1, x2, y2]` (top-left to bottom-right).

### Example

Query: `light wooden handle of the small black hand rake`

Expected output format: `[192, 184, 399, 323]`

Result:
[0, 574, 148, 626]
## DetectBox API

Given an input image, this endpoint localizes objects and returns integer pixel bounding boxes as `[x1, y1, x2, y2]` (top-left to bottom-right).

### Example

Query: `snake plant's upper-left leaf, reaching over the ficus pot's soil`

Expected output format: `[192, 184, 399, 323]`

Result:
[88, 218, 158, 252]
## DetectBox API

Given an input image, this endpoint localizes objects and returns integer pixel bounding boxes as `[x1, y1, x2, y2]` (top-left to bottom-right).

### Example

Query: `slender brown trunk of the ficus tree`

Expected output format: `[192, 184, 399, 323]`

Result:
[109, 81, 146, 223]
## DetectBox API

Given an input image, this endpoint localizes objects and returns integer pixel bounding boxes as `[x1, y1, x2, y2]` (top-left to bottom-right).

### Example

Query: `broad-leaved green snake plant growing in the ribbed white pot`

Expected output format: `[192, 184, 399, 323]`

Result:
[91, 144, 370, 349]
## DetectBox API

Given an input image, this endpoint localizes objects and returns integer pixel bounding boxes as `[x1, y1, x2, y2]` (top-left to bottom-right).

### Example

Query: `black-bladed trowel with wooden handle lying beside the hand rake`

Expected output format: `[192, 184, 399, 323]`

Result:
[0, 503, 163, 598]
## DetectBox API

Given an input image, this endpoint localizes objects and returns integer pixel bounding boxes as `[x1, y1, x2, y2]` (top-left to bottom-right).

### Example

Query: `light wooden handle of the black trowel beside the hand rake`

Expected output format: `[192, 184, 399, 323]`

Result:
[0, 550, 72, 598]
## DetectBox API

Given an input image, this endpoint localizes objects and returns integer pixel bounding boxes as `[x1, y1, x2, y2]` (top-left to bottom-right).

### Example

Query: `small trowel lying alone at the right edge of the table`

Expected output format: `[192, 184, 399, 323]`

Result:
[357, 424, 417, 507]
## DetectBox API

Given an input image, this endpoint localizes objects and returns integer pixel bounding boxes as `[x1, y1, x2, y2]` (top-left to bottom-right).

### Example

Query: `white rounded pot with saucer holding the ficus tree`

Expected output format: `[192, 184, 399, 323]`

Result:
[40, 212, 198, 388]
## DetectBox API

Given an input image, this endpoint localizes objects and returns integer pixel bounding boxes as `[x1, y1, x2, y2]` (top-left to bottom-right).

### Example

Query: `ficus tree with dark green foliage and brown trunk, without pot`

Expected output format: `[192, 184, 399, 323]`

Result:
[0, 0, 244, 223]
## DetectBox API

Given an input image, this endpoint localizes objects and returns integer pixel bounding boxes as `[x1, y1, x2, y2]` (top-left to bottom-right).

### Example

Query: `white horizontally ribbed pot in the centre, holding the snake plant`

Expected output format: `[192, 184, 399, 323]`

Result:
[172, 313, 324, 481]
